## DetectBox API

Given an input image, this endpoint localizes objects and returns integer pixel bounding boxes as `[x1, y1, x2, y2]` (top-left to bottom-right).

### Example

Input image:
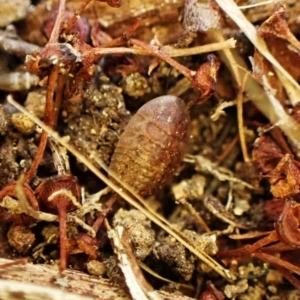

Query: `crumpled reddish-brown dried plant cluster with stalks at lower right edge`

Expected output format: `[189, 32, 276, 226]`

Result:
[219, 136, 300, 289]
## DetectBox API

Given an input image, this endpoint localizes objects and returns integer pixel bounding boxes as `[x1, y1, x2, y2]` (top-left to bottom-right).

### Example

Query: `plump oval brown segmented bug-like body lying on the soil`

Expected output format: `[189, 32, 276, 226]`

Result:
[110, 96, 190, 196]
